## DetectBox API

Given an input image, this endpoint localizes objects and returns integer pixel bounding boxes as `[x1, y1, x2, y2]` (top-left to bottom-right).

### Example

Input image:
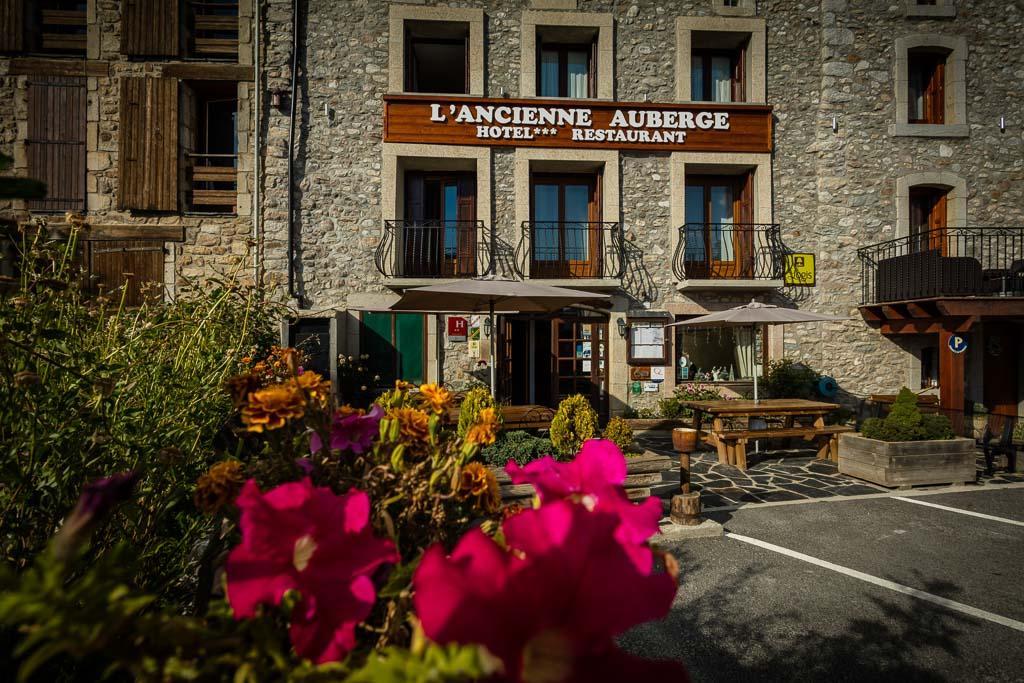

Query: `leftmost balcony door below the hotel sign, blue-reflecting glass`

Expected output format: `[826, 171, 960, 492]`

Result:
[399, 171, 477, 278]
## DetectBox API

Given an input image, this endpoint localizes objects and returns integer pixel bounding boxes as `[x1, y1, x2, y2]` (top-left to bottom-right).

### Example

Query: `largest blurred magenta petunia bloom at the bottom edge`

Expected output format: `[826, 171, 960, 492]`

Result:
[413, 501, 687, 683]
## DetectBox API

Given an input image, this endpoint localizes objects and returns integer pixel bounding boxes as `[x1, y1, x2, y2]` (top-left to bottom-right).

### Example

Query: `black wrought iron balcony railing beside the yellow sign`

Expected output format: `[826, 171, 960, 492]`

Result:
[672, 223, 790, 280]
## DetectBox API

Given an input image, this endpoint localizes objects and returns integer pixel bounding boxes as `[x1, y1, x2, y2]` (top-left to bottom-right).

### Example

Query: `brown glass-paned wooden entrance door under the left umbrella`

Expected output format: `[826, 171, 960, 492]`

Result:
[551, 318, 608, 418]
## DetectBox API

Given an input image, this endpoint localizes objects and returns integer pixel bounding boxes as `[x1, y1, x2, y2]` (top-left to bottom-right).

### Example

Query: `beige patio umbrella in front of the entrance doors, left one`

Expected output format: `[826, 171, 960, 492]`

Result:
[391, 278, 609, 395]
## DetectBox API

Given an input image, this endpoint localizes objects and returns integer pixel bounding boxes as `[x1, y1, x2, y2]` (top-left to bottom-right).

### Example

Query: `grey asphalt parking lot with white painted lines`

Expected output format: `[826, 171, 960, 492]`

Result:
[623, 484, 1024, 681]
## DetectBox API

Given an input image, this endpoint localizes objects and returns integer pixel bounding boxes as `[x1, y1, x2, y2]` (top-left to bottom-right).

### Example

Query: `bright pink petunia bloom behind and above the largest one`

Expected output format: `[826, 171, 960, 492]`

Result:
[505, 438, 662, 570]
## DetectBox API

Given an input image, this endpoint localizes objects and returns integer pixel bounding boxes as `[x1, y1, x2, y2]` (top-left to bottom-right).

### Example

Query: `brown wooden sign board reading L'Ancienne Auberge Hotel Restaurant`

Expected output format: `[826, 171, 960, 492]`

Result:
[384, 95, 772, 154]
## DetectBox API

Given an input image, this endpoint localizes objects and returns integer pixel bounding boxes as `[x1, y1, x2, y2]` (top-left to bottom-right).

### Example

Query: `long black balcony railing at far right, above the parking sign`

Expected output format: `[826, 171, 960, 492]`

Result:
[857, 227, 1024, 304]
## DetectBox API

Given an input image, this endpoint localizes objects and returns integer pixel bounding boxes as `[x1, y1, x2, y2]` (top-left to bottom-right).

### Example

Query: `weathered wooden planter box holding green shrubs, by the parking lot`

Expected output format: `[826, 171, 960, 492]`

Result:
[839, 433, 976, 487]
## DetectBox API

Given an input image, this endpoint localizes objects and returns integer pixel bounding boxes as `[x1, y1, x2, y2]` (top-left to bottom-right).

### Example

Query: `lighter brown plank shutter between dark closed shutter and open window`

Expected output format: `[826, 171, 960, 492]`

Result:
[118, 77, 178, 211]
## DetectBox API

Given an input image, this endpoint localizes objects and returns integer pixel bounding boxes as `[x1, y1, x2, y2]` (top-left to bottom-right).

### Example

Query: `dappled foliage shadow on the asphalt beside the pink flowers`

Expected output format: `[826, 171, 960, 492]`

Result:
[621, 542, 978, 683]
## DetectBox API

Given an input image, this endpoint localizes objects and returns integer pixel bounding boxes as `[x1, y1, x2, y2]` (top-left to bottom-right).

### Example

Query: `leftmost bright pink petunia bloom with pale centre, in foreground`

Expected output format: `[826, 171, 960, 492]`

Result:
[225, 478, 398, 664]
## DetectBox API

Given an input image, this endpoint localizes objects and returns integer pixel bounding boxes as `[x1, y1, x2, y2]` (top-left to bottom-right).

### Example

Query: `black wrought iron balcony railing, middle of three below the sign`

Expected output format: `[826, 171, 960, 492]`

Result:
[516, 220, 626, 280]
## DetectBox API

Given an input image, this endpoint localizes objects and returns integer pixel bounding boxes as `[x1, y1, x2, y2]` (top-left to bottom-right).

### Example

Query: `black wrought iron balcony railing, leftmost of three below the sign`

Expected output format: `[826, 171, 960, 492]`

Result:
[374, 220, 495, 278]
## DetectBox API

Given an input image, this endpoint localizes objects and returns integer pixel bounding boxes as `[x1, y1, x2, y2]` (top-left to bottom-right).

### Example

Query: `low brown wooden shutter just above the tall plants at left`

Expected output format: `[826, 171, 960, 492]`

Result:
[86, 240, 164, 306]
